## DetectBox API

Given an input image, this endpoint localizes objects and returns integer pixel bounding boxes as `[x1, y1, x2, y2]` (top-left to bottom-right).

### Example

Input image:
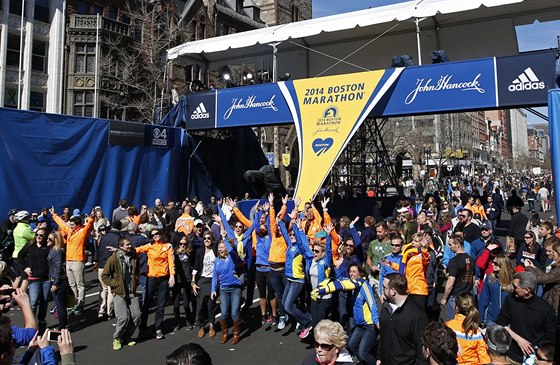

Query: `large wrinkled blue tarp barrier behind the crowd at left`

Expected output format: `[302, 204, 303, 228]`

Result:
[0, 108, 186, 217]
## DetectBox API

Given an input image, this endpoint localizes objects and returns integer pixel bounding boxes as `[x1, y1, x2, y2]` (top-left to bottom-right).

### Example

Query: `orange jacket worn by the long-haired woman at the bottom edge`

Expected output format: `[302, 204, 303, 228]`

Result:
[445, 314, 491, 365]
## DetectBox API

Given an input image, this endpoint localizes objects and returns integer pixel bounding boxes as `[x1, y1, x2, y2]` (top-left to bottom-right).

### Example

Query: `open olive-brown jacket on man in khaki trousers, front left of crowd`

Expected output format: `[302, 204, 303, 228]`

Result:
[101, 249, 138, 297]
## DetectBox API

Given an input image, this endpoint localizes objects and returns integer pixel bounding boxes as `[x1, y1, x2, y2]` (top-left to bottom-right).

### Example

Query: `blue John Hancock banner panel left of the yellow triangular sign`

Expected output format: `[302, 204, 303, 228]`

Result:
[216, 84, 293, 128]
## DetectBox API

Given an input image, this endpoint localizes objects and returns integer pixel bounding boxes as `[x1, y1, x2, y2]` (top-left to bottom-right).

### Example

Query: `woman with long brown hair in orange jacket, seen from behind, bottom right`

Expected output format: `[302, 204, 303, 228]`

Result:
[445, 293, 491, 365]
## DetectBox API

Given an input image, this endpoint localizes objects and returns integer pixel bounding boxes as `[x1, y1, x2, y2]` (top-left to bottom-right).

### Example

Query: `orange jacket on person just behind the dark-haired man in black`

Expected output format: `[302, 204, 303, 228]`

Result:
[402, 243, 430, 295]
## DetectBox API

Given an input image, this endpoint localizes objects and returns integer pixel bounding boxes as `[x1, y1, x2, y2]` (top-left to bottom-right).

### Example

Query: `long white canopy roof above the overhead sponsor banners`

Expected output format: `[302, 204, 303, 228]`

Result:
[167, 0, 560, 79]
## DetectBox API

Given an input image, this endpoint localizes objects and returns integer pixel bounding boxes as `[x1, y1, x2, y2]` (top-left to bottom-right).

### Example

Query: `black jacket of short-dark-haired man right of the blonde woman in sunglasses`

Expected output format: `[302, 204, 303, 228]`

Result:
[377, 298, 428, 365]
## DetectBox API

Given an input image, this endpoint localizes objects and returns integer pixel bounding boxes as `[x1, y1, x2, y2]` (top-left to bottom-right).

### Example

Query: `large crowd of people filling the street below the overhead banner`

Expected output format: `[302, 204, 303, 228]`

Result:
[0, 177, 560, 365]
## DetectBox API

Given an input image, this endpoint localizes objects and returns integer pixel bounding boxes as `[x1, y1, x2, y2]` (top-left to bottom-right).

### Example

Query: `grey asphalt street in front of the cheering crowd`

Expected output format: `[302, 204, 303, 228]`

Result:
[5, 203, 554, 365]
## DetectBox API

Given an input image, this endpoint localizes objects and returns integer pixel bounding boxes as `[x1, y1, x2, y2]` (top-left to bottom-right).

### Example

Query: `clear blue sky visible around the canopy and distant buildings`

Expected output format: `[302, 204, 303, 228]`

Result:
[313, 0, 560, 123]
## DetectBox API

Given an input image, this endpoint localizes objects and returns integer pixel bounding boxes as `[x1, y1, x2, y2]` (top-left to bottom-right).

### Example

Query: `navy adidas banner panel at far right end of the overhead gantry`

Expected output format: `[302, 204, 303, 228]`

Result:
[496, 52, 555, 106]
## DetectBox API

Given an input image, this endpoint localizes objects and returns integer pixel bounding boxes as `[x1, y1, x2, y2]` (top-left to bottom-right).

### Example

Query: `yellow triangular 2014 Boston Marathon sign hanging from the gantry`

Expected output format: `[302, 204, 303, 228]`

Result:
[278, 68, 403, 205]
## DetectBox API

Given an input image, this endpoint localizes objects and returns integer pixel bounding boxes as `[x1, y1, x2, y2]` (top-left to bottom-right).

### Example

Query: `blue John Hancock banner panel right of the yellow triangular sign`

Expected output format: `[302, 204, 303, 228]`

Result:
[374, 58, 497, 116]
